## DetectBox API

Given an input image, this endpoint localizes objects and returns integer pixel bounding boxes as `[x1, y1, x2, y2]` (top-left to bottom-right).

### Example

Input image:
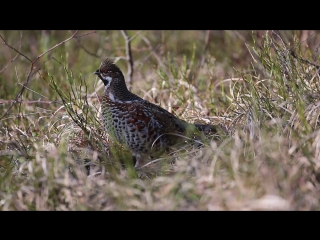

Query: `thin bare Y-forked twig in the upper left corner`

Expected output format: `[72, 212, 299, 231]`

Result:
[0, 30, 78, 119]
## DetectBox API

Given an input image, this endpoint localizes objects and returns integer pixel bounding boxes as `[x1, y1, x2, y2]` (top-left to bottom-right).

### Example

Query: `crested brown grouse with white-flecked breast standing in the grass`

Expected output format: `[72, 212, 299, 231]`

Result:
[94, 58, 222, 168]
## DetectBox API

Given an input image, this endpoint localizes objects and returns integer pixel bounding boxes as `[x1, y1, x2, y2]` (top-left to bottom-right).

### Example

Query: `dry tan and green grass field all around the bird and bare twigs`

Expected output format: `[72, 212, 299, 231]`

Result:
[0, 31, 320, 210]
